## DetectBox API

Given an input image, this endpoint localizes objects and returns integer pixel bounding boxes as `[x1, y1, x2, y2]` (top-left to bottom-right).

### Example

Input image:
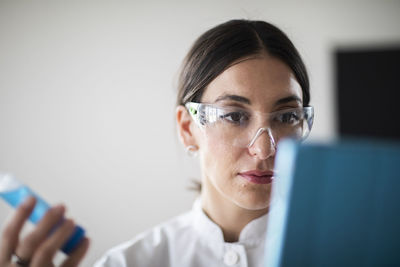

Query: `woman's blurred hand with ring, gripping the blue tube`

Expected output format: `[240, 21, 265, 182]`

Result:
[0, 197, 89, 267]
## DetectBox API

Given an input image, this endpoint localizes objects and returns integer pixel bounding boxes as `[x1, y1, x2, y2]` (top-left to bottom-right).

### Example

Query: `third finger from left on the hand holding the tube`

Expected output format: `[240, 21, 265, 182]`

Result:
[32, 219, 75, 266]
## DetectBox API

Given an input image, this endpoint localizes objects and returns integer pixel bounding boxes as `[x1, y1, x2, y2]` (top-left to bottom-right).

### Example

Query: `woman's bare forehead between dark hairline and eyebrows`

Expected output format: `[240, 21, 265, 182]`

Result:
[202, 55, 302, 107]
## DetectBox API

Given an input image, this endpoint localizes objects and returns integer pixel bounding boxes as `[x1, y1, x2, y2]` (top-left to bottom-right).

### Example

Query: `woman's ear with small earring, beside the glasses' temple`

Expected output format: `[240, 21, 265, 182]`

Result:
[175, 105, 198, 147]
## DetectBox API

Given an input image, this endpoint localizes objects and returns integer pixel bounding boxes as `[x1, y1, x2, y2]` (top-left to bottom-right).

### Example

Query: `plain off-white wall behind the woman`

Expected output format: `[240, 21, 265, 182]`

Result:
[0, 0, 400, 266]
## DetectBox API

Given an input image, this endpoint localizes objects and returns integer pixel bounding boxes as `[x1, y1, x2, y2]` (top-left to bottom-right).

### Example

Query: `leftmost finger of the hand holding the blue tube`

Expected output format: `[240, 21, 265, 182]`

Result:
[0, 197, 36, 263]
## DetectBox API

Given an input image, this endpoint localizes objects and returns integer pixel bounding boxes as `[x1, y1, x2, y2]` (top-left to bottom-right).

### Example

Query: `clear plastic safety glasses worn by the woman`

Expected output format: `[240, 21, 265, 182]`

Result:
[185, 102, 314, 147]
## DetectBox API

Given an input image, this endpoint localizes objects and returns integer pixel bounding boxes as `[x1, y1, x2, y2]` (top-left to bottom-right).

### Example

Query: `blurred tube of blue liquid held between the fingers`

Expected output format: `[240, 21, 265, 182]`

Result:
[0, 173, 85, 254]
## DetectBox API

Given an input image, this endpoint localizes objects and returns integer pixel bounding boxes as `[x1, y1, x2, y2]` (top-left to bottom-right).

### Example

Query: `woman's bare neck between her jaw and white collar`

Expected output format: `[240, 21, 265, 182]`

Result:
[201, 181, 268, 242]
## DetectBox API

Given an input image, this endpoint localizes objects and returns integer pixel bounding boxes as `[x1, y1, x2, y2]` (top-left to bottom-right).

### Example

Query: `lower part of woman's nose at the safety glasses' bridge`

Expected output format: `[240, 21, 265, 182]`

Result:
[247, 128, 276, 160]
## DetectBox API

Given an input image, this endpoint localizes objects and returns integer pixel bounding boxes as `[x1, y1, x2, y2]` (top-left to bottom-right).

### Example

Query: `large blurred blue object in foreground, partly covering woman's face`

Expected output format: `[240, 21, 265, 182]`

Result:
[265, 140, 400, 267]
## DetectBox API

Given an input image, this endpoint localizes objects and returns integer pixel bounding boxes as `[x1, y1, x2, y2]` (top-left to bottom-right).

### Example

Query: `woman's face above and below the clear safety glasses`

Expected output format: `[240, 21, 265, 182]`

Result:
[193, 54, 302, 210]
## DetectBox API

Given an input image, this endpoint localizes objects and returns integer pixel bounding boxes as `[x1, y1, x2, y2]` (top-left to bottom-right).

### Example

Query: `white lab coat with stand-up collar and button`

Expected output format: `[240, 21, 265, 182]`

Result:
[94, 200, 267, 267]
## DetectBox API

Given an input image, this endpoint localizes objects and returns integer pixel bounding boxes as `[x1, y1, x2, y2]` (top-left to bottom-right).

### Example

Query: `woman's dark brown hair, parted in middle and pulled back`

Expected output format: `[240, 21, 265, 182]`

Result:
[177, 20, 310, 106]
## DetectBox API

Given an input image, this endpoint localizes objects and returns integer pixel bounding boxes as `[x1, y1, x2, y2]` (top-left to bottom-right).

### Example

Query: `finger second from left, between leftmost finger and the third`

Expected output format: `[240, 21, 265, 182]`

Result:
[16, 205, 65, 259]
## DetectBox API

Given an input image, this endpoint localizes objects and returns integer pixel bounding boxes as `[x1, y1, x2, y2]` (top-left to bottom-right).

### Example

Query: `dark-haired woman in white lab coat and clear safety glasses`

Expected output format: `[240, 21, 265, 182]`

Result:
[1, 20, 313, 267]
